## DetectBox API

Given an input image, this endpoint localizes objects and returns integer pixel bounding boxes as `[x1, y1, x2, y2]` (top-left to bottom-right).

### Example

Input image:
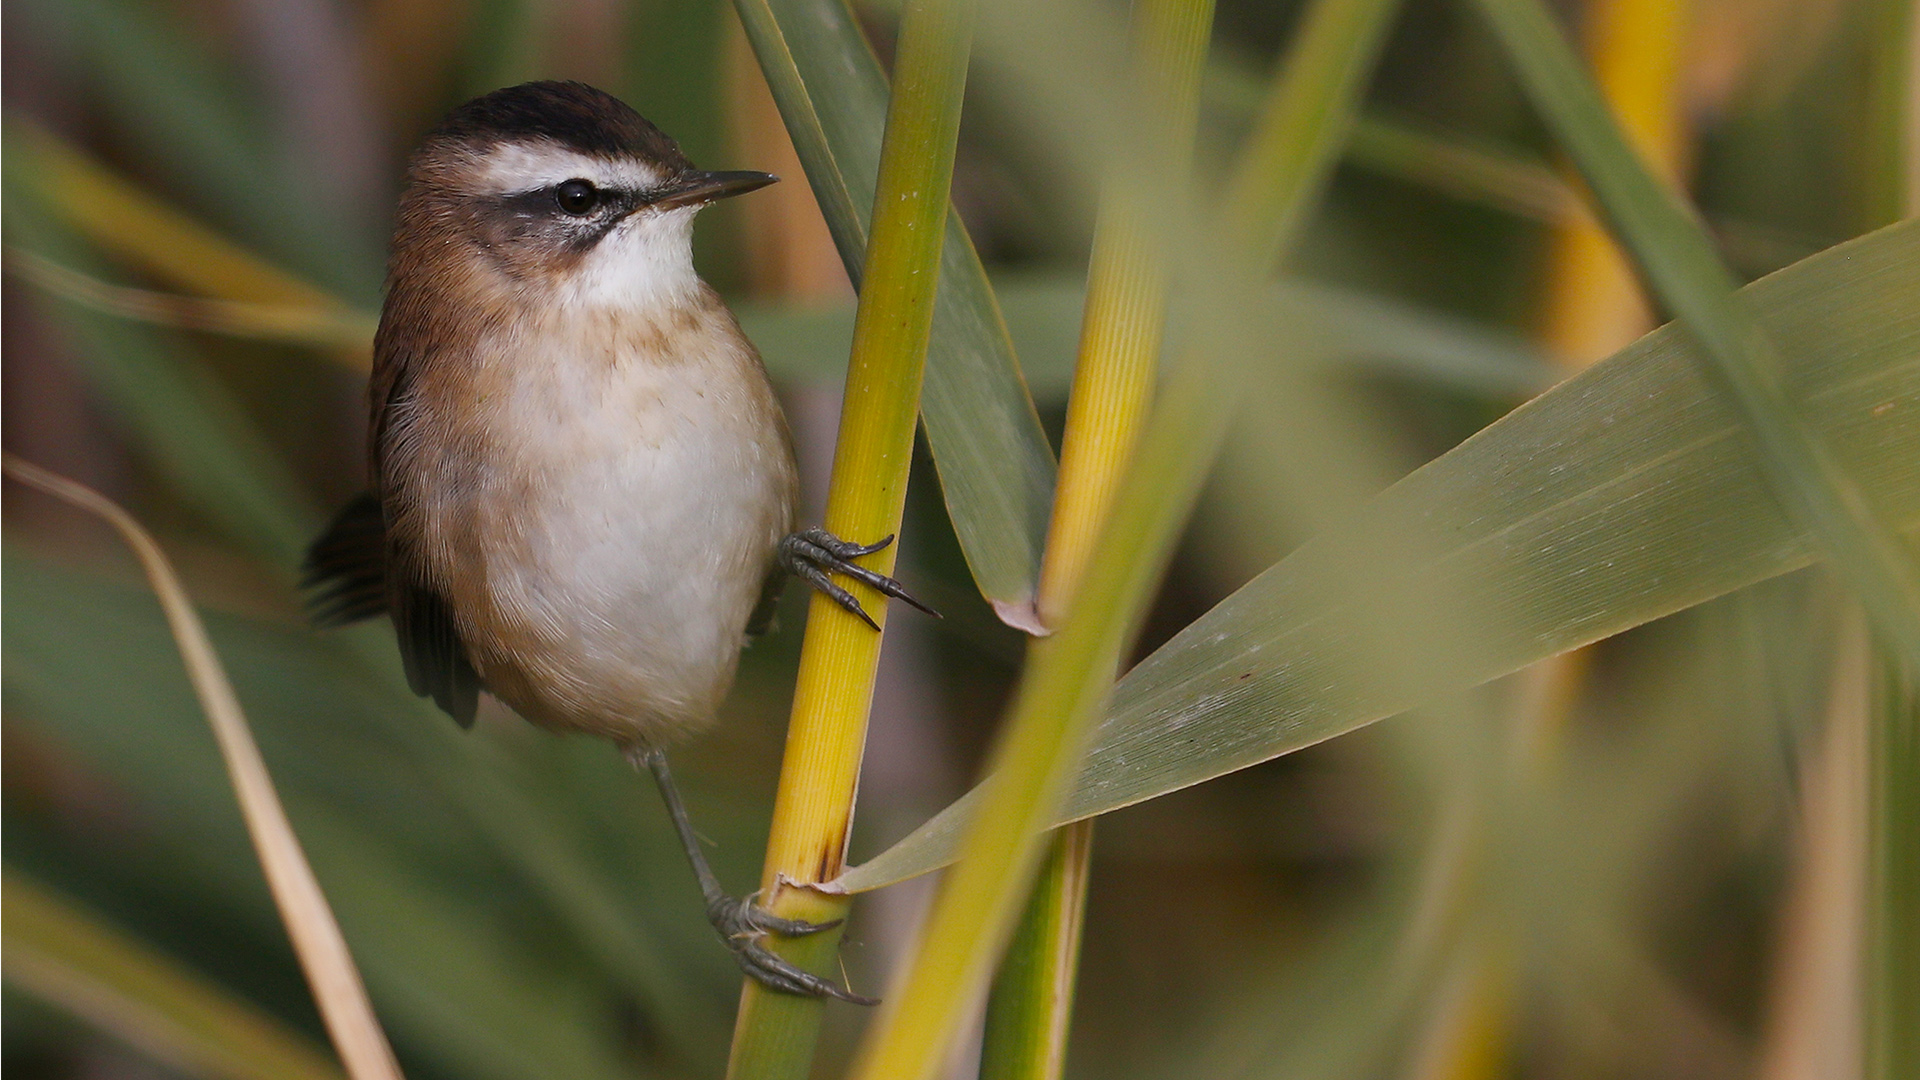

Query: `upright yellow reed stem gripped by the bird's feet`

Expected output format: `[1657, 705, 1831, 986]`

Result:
[728, 0, 973, 1078]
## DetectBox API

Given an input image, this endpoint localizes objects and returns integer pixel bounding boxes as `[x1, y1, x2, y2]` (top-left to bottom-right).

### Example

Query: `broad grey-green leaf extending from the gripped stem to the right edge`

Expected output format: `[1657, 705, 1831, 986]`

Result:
[837, 221, 1920, 892]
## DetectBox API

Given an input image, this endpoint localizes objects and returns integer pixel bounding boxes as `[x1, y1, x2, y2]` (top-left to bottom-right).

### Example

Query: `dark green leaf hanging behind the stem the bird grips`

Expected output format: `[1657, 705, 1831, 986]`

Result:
[735, 0, 1054, 613]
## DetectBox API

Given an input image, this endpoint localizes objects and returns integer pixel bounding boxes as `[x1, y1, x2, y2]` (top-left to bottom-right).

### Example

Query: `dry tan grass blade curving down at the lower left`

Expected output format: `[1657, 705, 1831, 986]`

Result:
[6, 454, 401, 1080]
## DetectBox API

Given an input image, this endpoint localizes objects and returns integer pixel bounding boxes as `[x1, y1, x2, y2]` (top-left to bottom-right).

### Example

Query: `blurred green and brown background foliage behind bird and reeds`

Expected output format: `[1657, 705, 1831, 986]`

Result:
[4, 0, 1910, 1080]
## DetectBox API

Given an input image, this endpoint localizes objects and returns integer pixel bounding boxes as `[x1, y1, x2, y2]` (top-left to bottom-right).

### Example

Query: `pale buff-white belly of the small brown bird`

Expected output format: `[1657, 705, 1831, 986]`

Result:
[434, 340, 793, 746]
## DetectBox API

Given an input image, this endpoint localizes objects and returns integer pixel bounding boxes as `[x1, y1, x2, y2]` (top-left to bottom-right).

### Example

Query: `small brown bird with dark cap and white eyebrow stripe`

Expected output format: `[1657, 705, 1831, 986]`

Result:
[303, 81, 931, 1003]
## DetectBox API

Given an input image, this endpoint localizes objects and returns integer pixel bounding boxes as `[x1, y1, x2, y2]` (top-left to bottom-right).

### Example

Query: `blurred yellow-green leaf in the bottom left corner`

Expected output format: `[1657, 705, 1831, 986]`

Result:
[0, 871, 342, 1080]
